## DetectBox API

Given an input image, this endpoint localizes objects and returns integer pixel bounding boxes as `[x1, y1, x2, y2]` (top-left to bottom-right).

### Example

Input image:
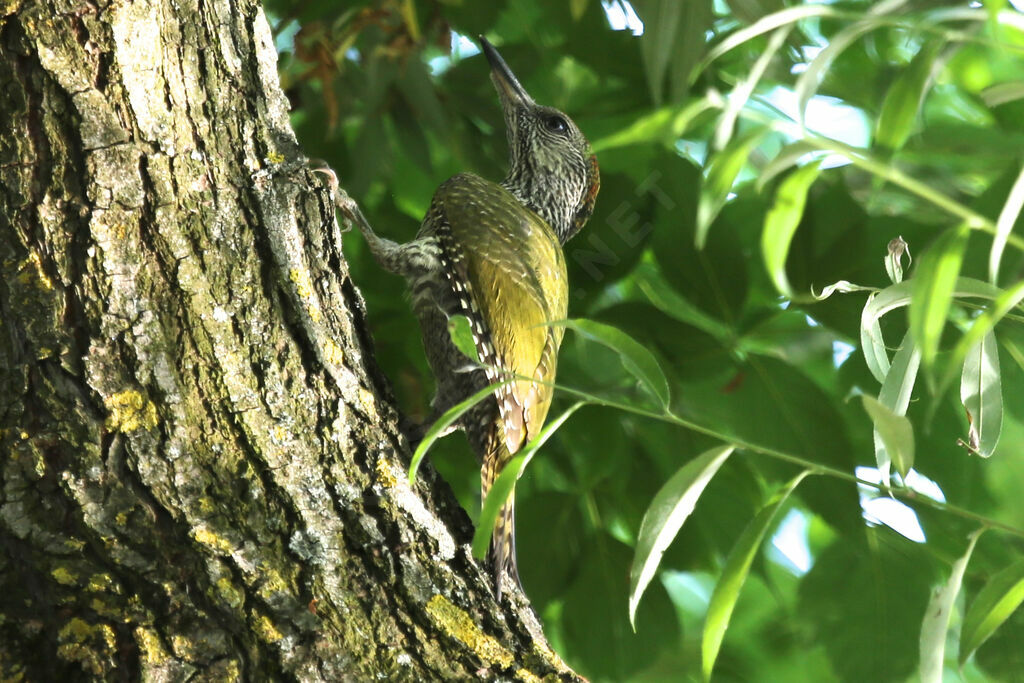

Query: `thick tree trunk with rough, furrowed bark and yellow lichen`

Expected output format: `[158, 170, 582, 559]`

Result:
[0, 0, 571, 680]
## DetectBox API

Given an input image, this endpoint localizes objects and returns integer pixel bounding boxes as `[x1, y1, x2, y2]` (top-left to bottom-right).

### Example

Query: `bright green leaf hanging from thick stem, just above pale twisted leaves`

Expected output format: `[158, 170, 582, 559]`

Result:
[910, 224, 970, 368]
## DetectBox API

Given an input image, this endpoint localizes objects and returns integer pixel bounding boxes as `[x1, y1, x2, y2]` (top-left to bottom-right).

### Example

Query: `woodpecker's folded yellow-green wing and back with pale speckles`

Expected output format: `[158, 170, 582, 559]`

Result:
[434, 173, 568, 454]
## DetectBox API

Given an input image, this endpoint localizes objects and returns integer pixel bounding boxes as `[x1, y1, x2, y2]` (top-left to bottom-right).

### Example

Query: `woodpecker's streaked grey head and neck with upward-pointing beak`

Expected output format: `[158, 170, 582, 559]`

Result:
[480, 36, 601, 245]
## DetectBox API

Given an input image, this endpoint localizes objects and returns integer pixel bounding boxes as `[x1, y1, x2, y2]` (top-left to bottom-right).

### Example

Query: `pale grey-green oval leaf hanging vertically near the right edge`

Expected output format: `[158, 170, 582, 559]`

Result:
[961, 331, 1002, 458]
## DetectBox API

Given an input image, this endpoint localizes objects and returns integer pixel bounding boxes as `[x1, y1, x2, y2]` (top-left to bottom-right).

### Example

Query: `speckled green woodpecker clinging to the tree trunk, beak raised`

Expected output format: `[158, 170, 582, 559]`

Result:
[335, 37, 600, 599]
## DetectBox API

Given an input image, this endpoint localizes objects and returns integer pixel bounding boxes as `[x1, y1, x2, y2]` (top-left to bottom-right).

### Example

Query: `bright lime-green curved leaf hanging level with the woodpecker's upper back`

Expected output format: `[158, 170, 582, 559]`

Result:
[761, 161, 821, 297]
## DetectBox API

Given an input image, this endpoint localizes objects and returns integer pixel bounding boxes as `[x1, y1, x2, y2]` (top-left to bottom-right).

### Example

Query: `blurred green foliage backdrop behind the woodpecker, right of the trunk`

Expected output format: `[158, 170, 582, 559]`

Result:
[267, 0, 1024, 681]
